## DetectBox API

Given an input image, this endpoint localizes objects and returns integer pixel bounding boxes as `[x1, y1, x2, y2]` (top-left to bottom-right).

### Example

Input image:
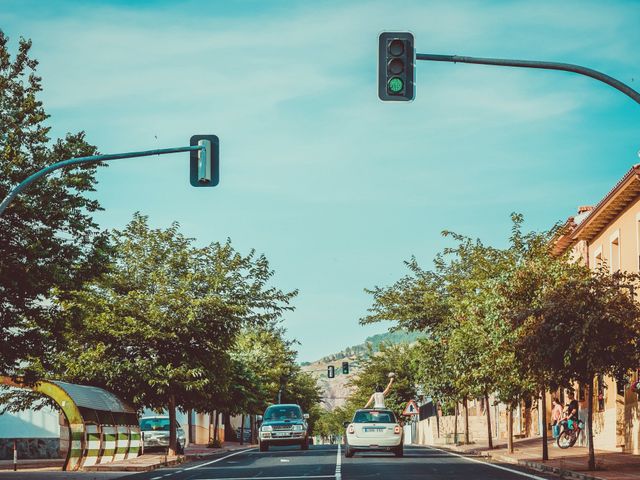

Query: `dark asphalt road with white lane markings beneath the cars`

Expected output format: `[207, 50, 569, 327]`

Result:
[115, 445, 556, 480]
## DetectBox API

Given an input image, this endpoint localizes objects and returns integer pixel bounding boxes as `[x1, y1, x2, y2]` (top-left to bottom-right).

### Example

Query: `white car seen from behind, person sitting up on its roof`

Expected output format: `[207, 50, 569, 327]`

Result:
[344, 408, 404, 457]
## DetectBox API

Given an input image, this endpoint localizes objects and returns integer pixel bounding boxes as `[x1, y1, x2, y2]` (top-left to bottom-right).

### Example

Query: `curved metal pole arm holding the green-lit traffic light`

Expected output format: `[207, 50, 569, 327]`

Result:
[416, 53, 640, 104]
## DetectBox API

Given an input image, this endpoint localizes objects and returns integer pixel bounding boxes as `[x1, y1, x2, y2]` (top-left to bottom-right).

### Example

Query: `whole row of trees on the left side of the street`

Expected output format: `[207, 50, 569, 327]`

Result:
[0, 31, 319, 454]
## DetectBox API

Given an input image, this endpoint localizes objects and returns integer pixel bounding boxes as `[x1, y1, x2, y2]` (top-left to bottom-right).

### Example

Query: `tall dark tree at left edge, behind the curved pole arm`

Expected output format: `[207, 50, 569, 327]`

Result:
[0, 31, 108, 381]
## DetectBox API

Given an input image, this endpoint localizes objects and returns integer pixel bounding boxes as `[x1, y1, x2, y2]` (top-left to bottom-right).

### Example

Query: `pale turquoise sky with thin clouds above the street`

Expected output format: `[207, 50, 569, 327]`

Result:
[0, 0, 640, 361]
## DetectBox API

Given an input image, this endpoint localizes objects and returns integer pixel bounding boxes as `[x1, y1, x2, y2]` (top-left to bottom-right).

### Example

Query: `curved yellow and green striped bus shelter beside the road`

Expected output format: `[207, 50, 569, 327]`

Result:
[2, 377, 140, 470]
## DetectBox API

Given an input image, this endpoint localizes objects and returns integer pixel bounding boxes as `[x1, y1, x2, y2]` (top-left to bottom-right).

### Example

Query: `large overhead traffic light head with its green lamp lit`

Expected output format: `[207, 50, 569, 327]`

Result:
[378, 32, 415, 102]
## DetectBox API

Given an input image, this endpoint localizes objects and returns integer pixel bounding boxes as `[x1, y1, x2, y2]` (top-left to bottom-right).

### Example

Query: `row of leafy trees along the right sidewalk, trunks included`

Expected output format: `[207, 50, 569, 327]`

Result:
[361, 214, 640, 469]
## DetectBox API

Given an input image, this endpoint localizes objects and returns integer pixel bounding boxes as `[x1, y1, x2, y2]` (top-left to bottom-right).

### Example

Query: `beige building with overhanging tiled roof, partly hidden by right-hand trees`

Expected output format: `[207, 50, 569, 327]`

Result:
[554, 164, 640, 454]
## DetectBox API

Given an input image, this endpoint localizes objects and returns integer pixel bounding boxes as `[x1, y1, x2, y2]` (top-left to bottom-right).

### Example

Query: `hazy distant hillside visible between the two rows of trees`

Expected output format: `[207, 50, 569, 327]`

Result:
[301, 332, 422, 410]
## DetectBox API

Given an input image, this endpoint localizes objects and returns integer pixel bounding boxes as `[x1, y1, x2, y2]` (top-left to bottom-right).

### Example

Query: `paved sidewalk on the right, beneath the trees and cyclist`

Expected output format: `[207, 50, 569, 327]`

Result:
[438, 438, 640, 480]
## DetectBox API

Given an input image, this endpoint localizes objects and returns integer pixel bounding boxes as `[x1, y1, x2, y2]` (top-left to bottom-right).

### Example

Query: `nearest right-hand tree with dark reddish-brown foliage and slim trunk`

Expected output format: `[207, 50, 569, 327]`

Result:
[538, 267, 640, 470]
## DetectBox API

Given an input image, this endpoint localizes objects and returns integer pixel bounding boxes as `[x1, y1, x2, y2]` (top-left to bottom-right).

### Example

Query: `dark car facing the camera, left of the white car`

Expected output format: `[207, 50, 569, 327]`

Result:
[258, 404, 309, 452]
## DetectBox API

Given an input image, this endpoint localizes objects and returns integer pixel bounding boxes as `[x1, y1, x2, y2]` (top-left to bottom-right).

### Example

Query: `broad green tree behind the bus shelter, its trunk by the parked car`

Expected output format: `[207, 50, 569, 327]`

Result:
[57, 214, 296, 451]
